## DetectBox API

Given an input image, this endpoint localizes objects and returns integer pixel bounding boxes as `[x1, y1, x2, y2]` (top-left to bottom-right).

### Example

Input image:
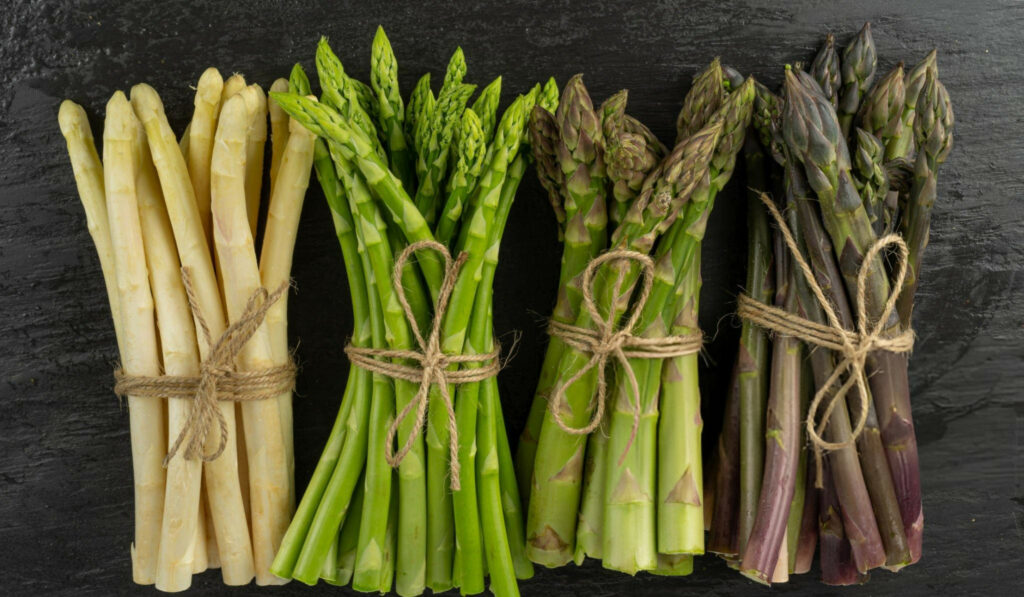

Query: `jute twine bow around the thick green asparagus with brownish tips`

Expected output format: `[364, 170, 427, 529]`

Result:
[548, 249, 703, 460]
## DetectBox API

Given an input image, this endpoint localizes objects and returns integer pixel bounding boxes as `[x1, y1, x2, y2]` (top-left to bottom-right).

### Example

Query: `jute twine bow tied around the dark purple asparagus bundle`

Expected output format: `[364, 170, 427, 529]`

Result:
[736, 195, 913, 487]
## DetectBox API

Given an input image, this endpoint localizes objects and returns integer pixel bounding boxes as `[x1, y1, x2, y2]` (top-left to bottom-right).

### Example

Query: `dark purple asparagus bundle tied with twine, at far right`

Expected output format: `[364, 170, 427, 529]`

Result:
[709, 26, 953, 585]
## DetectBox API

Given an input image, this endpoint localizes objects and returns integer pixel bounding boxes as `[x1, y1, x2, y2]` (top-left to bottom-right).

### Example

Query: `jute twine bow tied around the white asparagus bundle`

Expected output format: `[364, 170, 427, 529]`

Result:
[114, 267, 296, 467]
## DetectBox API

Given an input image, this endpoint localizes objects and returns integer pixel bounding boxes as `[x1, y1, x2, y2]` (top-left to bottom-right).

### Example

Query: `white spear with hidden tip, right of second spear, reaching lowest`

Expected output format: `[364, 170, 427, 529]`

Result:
[135, 121, 206, 592]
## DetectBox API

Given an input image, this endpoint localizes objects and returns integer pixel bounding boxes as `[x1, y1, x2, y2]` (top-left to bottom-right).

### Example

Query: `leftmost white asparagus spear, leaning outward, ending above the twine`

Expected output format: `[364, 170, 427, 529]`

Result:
[57, 99, 124, 354]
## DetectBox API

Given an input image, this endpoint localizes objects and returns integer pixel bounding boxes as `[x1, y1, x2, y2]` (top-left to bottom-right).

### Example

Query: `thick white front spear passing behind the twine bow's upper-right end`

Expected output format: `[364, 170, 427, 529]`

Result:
[211, 95, 290, 585]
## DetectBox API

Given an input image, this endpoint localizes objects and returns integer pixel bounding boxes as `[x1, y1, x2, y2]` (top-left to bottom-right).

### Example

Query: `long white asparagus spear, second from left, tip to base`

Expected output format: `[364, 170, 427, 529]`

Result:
[103, 91, 166, 585]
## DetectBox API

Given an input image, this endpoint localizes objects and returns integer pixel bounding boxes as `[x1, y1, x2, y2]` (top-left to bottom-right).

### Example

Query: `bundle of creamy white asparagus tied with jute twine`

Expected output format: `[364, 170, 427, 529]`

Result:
[59, 64, 313, 591]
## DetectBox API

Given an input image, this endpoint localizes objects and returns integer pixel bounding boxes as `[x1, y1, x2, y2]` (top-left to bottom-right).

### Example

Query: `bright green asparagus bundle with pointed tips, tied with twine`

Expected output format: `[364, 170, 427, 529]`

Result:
[271, 29, 557, 595]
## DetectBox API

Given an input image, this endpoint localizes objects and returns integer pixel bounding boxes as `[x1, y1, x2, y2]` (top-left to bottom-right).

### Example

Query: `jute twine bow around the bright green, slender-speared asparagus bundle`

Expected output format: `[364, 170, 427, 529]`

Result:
[345, 241, 501, 491]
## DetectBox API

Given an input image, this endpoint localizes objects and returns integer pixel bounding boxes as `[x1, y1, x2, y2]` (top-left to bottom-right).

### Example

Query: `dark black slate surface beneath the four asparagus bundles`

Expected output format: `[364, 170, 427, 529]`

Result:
[0, 0, 1024, 596]
